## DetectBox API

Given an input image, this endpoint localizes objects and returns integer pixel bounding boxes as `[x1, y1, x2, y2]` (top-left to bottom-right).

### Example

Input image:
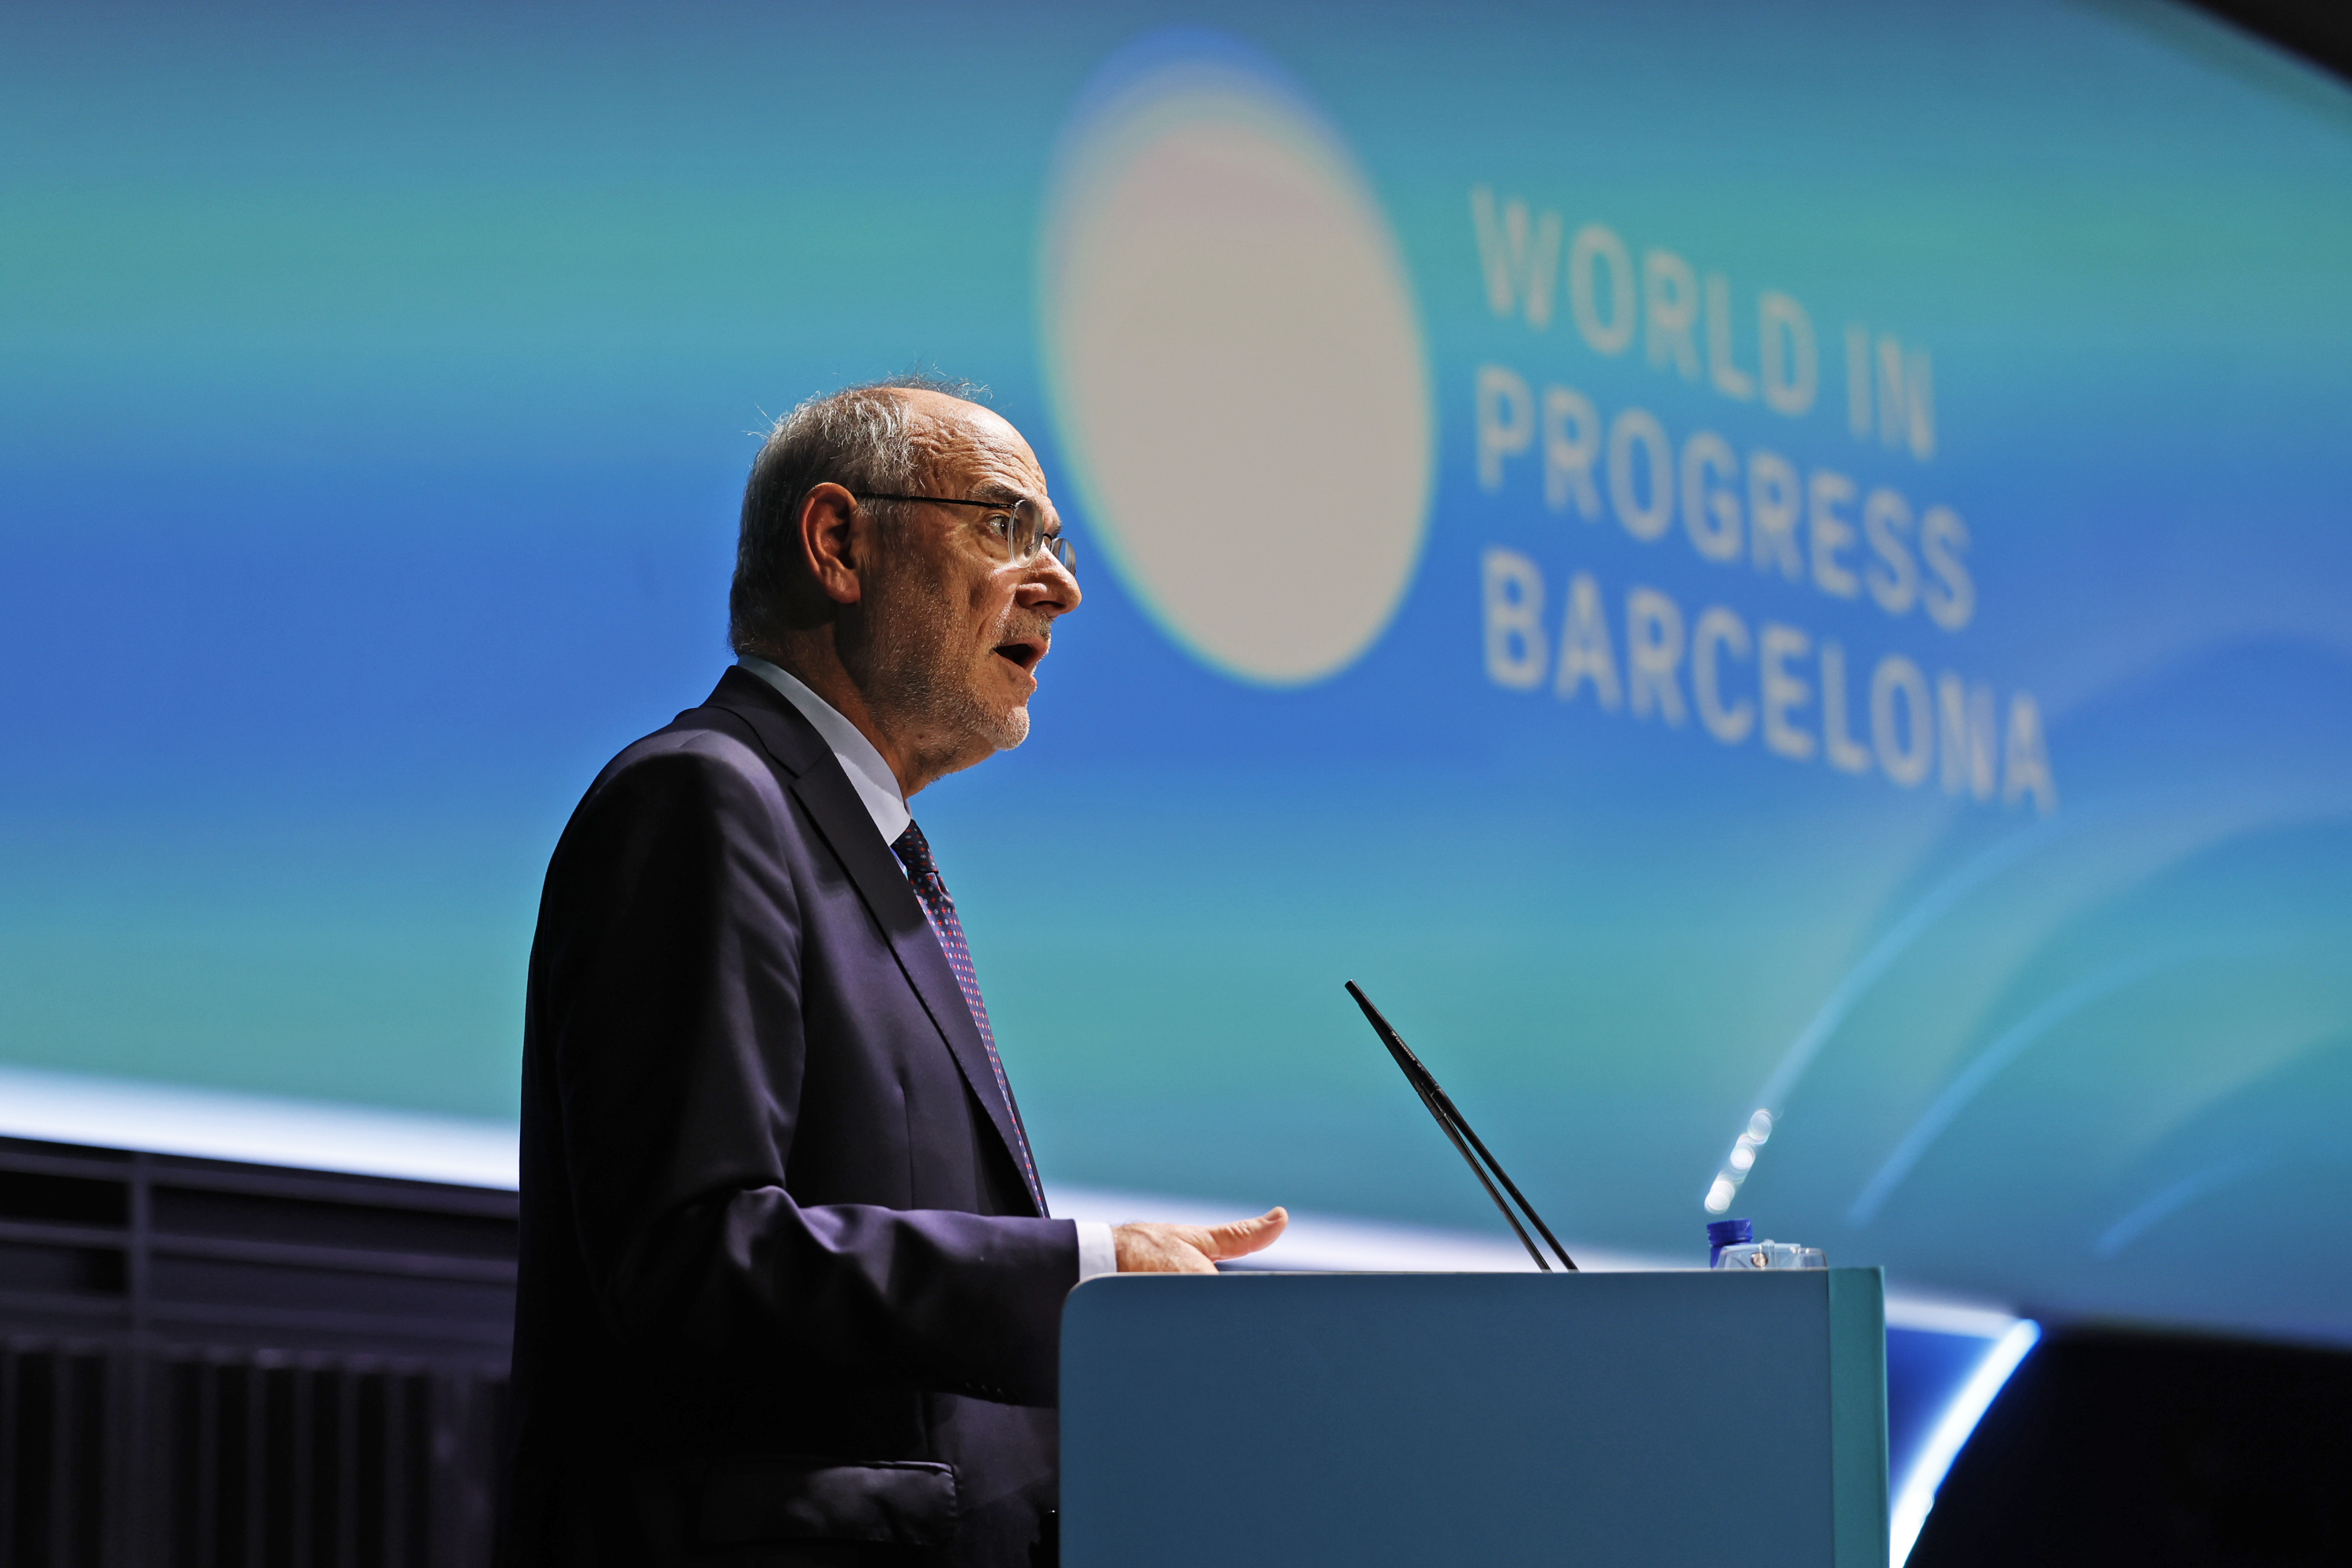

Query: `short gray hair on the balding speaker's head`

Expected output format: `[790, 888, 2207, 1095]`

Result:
[727, 376, 988, 654]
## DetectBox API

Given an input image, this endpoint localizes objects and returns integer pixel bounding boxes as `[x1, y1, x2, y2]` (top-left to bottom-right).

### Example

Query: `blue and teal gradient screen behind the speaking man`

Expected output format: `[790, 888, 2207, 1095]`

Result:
[0, 2, 2352, 1337]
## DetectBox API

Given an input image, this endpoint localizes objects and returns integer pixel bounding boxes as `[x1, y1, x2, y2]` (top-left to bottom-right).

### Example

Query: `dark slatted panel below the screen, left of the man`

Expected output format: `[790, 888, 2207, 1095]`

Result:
[0, 1140, 515, 1568]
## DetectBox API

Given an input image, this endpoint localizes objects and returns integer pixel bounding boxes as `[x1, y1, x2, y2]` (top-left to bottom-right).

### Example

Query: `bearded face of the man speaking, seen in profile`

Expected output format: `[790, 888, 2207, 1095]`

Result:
[858, 393, 1080, 771]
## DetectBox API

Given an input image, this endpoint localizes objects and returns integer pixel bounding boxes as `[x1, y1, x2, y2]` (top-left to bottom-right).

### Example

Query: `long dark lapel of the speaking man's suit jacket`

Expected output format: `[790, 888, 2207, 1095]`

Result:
[686, 668, 1035, 1204]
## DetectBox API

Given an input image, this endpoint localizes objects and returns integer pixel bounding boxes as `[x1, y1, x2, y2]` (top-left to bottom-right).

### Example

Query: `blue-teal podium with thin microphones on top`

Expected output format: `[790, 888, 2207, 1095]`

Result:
[1061, 1269, 1886, 1568]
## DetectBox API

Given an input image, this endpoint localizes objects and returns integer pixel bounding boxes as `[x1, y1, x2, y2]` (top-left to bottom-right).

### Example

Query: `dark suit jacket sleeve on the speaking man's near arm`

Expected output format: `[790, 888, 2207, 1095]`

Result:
[532, 733, 1077, 1404]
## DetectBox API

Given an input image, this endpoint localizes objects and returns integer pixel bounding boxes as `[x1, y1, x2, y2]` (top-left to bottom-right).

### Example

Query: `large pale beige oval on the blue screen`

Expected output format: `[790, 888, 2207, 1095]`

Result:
[1039, 40, 1432, 684]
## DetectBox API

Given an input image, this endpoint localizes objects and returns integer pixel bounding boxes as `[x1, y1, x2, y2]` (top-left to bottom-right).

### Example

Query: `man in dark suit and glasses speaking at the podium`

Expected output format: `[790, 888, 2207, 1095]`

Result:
[503, 381, 1284, 1568]
